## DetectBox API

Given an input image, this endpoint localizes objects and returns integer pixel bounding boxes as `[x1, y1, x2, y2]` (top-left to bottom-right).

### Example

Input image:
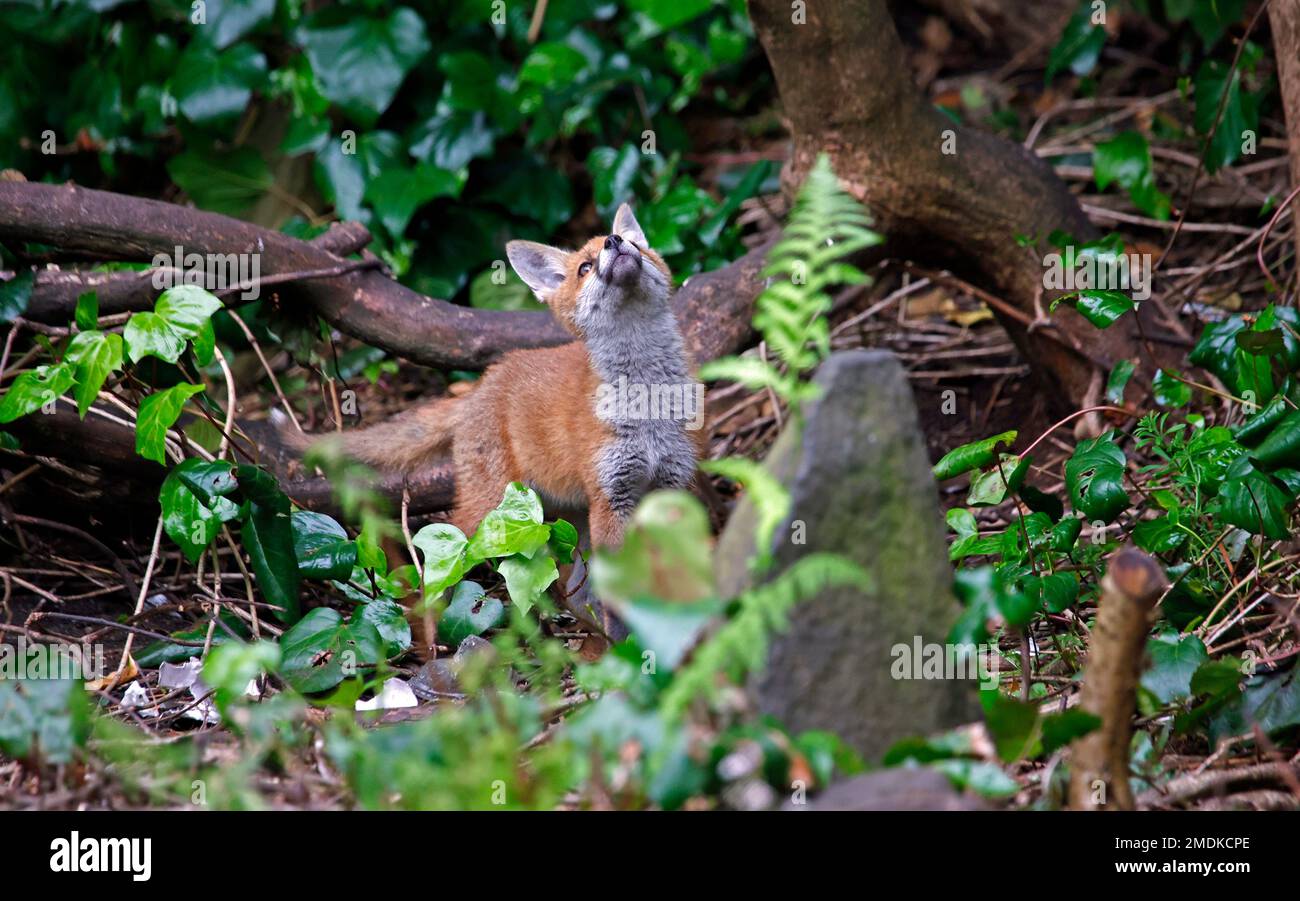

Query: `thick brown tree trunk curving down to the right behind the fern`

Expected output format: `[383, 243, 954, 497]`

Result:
[749, 0, 1138, 404]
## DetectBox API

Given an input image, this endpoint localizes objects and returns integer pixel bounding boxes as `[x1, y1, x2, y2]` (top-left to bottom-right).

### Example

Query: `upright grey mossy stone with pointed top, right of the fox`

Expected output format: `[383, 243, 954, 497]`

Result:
[718, 351, 978, 759]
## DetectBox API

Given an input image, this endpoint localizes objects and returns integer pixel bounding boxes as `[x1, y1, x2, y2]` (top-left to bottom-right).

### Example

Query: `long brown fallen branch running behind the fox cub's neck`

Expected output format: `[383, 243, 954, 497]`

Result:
[0, 182, 766, 369]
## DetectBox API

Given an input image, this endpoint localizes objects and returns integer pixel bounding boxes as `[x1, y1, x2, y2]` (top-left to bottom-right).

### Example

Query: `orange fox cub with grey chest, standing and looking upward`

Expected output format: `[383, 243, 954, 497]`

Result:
[293, 204, 705, 546]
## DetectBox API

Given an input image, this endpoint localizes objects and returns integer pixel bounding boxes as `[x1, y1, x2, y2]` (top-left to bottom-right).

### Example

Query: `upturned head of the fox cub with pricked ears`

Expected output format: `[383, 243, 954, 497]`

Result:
[506, 204, 672, 338]
